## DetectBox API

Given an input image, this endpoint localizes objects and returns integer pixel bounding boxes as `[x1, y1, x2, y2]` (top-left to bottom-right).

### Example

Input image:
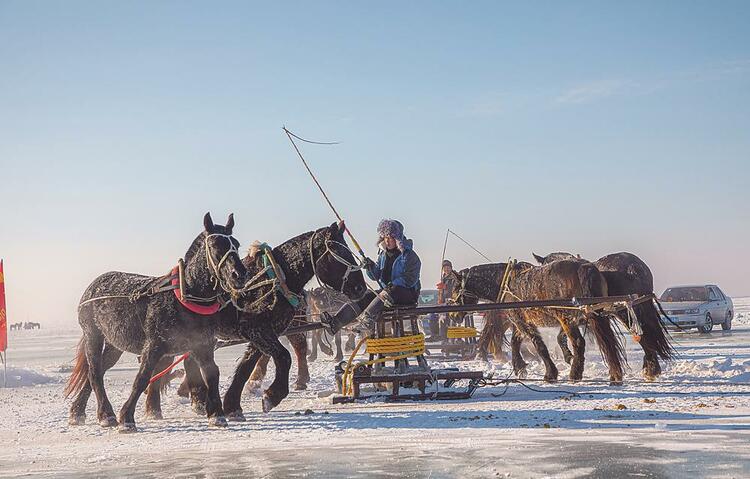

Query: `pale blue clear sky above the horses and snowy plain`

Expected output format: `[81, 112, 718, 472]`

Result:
[0, 0, 750, 325]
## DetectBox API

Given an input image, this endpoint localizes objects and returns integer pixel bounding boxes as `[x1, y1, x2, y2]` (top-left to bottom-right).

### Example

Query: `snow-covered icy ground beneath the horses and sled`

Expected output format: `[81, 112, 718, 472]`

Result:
[0, 298, 750, 478]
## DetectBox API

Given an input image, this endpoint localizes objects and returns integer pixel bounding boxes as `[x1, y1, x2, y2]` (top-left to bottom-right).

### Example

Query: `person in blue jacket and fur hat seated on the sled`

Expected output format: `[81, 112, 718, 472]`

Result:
[320, 219, 422, 333]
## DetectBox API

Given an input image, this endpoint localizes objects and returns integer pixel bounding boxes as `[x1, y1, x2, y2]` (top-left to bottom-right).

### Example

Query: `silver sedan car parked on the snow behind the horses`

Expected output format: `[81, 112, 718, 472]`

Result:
[659, 284, 734, 333]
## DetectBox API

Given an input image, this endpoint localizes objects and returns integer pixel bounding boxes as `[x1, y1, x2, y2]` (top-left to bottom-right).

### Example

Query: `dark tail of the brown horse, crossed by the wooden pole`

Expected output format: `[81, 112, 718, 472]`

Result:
[578, 264, 628, 378]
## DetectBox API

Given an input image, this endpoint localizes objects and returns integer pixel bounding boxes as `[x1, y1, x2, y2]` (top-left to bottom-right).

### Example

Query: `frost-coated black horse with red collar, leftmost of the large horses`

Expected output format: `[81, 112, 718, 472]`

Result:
[65, 213, 247, 432]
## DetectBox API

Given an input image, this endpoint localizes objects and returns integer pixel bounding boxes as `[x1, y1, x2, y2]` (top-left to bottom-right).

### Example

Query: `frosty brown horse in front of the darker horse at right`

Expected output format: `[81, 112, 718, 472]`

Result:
[453, 259, 626, 384]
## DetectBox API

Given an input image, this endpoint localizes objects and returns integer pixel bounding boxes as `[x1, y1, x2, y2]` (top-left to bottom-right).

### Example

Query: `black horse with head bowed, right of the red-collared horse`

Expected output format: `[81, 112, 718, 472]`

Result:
[179, 223, 372, 421]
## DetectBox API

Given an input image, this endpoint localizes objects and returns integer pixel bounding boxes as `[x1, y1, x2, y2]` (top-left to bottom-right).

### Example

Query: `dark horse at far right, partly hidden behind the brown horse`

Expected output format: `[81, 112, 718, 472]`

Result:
[532, 252, 675, 380]
